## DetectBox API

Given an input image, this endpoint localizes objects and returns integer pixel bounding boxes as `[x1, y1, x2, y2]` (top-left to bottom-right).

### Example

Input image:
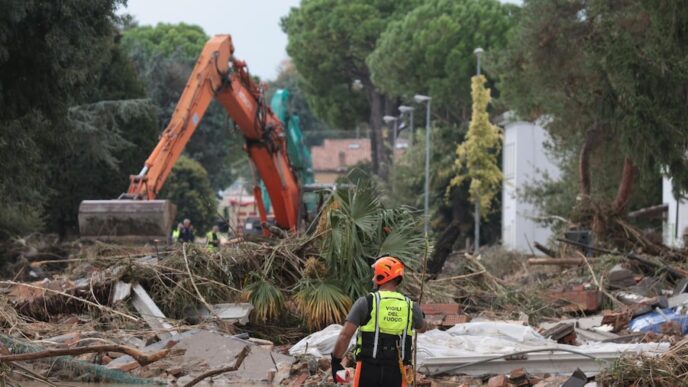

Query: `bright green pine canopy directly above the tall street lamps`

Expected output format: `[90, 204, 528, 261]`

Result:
[368, 0, 519, 122]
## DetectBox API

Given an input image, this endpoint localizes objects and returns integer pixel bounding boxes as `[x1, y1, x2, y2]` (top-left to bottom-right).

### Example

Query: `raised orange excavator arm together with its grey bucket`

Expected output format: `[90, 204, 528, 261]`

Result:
[79, 35, 301, 240]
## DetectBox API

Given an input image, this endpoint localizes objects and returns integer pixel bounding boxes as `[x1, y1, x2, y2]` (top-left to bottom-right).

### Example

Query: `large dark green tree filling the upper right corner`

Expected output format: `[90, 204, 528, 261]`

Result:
[493, 0, 688, 218]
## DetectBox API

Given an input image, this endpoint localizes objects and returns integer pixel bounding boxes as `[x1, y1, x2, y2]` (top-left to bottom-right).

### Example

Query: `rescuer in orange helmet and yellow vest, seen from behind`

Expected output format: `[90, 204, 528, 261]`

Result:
[332, 256, 430, 387]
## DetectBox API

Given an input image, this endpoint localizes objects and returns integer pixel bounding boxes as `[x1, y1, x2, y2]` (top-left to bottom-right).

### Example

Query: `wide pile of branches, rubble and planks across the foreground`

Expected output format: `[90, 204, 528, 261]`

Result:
[0, 229, 688, 386]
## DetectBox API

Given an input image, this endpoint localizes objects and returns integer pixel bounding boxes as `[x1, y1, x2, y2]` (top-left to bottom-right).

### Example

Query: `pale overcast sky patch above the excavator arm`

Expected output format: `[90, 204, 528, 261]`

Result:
[121, 0, 522, 80]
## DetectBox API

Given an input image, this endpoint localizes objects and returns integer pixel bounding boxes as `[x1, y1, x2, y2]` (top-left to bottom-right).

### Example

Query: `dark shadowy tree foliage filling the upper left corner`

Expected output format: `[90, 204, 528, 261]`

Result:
[0, 0, 129, 238]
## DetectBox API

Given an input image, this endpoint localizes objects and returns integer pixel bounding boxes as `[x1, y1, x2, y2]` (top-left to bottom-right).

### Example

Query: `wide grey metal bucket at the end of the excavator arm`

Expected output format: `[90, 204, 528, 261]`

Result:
[79, 199, 177, 242]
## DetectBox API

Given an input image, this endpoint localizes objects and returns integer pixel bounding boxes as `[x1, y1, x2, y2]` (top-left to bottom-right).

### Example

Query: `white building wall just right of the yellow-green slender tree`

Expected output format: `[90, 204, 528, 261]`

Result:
[502, 121, 560, 254]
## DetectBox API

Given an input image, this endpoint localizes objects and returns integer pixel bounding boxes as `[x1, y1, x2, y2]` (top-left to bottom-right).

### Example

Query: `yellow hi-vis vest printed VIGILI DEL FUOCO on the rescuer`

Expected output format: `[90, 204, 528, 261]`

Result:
[357, 291, 414, 360]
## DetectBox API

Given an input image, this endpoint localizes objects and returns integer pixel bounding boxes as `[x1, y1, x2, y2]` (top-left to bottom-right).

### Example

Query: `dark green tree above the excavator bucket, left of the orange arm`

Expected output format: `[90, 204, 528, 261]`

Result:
[45, 99, 159, 236]
